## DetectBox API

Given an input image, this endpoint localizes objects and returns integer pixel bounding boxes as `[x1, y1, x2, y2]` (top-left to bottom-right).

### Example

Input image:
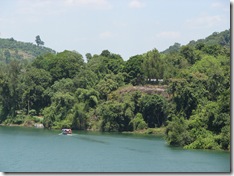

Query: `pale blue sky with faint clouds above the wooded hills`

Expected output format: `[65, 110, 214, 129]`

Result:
[0, 0, 230, 60]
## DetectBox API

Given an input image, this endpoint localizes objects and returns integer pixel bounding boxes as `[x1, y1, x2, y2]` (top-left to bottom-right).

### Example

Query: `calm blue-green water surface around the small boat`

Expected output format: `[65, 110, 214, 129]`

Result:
[0, 126, 230, 172]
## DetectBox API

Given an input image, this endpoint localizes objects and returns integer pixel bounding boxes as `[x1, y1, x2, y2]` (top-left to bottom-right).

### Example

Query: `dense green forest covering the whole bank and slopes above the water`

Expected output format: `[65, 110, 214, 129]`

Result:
[0, 30, 231, 150]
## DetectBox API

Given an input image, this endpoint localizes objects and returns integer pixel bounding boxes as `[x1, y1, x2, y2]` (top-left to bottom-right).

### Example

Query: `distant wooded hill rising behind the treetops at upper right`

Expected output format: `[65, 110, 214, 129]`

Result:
[161, 29, 231, 54]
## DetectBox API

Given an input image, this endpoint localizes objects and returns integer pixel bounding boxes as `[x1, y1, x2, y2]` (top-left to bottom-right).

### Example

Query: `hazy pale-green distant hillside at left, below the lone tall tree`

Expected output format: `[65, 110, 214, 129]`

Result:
[0, 38, 56, 63]
